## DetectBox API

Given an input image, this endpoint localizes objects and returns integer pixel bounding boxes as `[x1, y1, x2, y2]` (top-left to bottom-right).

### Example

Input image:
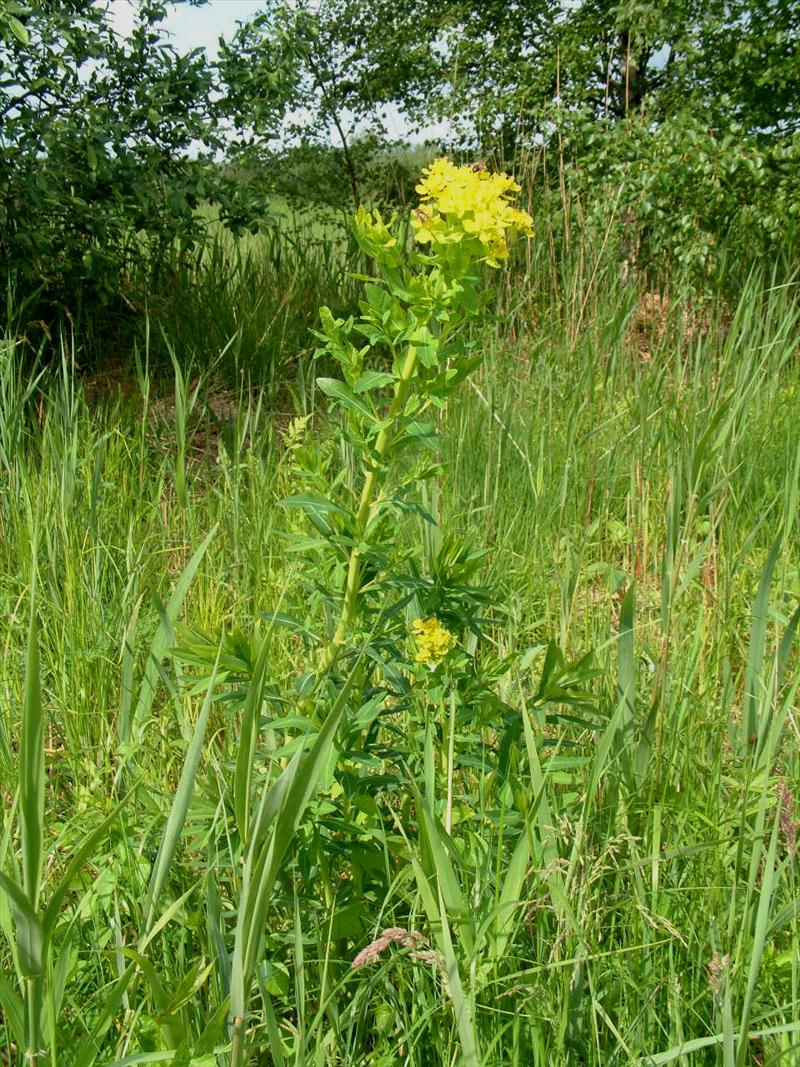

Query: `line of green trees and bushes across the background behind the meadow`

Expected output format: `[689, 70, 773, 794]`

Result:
[0, 0, 800, 341]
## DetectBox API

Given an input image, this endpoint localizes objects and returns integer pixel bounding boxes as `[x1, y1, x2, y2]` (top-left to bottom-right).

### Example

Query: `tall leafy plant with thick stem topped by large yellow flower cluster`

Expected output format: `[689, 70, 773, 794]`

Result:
[302, 158, 533, 690]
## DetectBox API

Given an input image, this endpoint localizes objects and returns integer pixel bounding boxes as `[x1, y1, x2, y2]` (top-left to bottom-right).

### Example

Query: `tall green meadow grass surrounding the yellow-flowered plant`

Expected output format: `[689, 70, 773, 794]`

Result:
[0, 205, 800, 1067]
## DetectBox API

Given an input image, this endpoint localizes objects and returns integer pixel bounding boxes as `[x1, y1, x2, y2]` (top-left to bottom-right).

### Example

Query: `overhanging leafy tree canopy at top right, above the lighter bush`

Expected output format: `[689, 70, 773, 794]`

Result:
[294, 0, 800, 145]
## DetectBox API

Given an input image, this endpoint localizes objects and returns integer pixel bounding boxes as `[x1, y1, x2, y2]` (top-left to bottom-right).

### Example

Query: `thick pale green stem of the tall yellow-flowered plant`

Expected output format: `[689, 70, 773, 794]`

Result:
[317, 346, 417, 680]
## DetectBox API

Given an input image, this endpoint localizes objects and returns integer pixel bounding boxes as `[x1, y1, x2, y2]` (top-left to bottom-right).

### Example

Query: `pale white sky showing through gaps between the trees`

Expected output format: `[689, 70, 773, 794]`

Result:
[109, 0, 449, 141]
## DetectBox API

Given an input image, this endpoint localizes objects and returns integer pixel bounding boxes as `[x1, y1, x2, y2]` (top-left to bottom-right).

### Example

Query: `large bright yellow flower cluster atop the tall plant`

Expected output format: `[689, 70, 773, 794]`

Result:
[411, 158, 533, 267]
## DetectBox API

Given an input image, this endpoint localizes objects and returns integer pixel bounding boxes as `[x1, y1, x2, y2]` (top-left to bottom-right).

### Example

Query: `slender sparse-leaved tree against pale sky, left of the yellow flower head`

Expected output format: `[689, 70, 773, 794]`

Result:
[221, 0, 439, 207]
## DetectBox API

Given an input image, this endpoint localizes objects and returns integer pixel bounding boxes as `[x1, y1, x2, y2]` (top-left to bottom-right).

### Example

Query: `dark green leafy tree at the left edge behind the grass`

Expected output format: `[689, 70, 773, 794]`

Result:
[0, 0, 285, 322]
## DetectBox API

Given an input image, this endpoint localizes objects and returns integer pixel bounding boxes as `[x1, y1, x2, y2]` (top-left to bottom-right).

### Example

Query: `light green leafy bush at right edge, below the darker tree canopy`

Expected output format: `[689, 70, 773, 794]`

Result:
[562, 111, 800, 279]
